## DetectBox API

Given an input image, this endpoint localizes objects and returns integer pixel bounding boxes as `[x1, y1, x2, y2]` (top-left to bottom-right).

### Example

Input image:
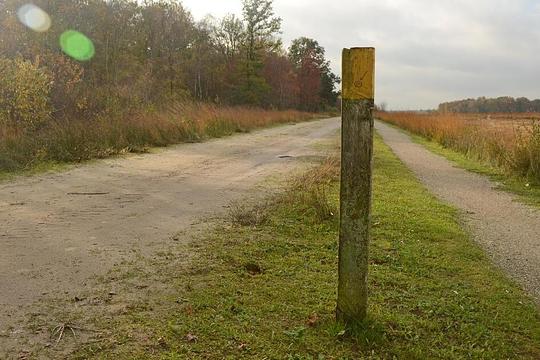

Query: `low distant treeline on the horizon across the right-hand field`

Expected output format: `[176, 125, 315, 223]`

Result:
[439, 96, 540, 113]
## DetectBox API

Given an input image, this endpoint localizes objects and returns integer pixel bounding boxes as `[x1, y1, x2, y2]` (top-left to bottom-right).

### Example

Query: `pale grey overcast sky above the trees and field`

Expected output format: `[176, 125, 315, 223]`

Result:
[183, 0, 540, 109]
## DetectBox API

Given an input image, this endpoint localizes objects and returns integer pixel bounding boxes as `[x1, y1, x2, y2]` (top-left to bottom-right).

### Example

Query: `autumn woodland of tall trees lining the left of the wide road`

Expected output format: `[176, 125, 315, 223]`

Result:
[0, 0, 339, 129]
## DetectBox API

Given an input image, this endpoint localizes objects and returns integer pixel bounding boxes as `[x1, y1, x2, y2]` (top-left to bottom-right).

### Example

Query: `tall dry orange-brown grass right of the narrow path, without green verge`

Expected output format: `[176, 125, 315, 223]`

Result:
[377, 112, 540, 182]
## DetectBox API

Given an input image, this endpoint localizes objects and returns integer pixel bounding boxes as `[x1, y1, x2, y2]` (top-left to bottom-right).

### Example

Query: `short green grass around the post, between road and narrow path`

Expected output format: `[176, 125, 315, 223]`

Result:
[75, 139, 540, 360]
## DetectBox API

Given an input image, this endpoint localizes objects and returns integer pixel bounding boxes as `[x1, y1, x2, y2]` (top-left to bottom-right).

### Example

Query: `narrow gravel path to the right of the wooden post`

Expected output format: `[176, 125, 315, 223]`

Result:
[375, 121, 540, 302]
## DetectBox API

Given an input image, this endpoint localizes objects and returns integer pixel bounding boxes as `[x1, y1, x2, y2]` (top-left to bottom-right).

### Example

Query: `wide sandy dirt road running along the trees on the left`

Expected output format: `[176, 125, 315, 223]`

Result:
[0, 119, 340, 357]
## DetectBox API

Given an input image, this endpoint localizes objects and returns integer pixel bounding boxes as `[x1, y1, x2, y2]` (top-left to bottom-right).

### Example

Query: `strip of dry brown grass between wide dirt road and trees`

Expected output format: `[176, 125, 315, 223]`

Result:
[0, 103, 315, 172]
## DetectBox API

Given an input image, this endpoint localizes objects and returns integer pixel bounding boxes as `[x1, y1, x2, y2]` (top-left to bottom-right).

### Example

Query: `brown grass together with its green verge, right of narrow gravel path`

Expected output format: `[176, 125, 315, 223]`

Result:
[377, 112, 540, 207]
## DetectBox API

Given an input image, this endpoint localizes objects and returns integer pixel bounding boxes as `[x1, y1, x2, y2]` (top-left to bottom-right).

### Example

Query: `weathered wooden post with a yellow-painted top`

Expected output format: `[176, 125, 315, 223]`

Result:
[336, 48, 375, 324]
